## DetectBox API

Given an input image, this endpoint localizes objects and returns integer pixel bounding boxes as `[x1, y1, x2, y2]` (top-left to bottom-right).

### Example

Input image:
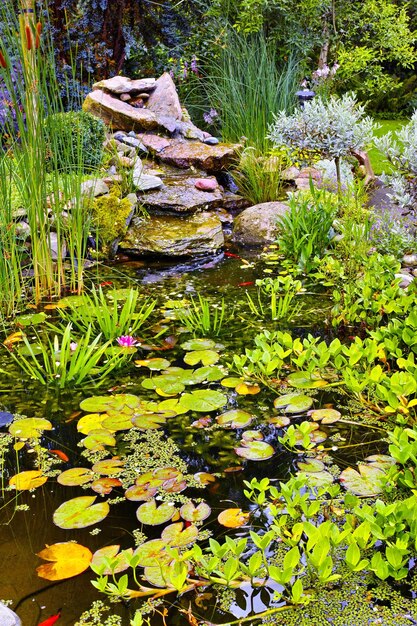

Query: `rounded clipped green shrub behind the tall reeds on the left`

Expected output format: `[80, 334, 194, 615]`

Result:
[45, 111, 106, 170]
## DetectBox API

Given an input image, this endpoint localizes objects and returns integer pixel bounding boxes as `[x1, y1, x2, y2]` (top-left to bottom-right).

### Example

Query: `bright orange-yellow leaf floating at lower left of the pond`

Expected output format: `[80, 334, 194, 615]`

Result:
[36, 541, 93, 580]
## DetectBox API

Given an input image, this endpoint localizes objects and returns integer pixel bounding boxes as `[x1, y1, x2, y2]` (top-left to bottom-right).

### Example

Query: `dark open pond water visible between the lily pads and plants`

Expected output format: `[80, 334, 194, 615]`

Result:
[0, 253, 386, 626]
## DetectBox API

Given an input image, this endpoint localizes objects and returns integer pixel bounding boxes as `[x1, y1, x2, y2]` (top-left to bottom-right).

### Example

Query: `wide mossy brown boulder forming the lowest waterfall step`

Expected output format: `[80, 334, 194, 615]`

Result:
[119, 212, 224, 257]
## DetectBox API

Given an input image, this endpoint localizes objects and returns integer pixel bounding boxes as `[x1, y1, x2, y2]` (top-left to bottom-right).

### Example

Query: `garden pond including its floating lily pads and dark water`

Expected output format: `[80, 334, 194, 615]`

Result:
[0, 250, 417, 626]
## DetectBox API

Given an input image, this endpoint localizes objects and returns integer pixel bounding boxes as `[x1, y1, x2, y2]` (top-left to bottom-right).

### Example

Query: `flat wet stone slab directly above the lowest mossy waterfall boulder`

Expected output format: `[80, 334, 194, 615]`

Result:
[141, 176, 223, 213]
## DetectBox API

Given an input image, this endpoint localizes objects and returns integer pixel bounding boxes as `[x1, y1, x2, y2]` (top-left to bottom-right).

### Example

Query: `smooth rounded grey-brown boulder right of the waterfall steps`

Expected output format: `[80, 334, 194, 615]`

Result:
[233, 202, 289, 246]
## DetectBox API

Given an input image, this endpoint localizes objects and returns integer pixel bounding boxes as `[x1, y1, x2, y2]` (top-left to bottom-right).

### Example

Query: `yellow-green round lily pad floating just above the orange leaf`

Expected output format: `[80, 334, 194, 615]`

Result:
[53, 496, 110, 529]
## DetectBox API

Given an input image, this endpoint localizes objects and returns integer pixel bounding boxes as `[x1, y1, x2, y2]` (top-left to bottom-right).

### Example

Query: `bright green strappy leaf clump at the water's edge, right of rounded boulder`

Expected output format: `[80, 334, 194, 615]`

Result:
[277, 182, 337, 272]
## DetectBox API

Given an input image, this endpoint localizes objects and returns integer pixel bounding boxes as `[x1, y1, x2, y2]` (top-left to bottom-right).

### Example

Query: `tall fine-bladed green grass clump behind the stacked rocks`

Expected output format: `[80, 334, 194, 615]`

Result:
[205, 30, 300, 153]
